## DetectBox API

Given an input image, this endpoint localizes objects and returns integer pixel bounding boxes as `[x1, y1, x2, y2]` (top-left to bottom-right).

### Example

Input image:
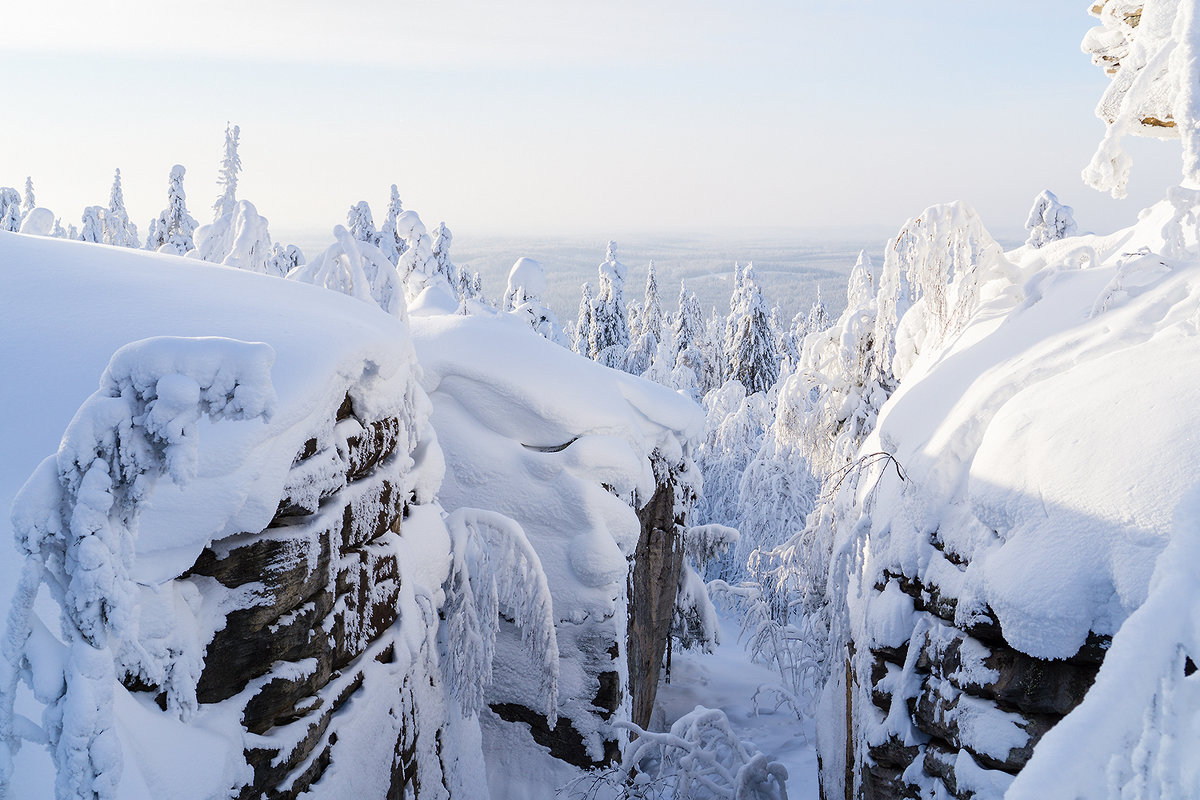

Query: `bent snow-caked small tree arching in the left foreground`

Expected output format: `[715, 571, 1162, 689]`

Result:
[0, 337, 275, 800]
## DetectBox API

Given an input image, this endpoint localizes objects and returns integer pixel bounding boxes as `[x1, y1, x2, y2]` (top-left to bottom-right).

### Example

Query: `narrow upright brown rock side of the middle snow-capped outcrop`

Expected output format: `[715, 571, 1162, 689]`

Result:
[628, 481, 684, 728]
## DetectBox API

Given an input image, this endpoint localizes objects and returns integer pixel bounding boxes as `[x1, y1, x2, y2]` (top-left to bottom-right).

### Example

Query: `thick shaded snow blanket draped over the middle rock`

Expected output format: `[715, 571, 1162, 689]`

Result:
[412, 313, 703, 798]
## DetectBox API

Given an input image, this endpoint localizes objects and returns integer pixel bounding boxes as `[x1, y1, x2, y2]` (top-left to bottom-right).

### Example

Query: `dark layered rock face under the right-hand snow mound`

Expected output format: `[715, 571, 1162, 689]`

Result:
[848, 573, 1110, 800]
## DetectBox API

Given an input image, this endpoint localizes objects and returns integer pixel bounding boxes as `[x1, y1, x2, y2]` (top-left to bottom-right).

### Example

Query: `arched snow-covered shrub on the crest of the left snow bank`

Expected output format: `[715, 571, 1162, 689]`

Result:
[287, 225, 408, 319]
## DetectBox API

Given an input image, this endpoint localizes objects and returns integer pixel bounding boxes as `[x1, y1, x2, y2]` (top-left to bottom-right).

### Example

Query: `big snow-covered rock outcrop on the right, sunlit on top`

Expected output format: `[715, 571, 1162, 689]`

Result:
[822, 196, 1200, 798]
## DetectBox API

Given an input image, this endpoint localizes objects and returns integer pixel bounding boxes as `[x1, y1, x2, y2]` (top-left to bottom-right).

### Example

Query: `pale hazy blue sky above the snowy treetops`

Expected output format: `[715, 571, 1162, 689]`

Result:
[0, 0, 1178, 239]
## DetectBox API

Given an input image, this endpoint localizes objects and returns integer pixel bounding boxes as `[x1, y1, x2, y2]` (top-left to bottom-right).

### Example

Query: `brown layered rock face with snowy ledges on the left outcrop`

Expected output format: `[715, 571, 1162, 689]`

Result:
[170, 397, 445, 800]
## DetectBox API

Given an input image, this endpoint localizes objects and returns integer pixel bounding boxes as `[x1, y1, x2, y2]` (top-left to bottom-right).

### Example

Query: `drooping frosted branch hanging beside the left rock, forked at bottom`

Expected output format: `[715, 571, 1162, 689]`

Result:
[443, 509, 558, 727]
